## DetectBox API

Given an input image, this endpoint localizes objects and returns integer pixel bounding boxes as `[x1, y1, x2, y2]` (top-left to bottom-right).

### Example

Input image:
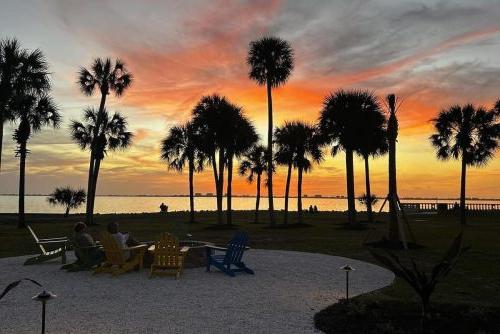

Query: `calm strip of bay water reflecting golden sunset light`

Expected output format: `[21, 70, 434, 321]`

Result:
[0, 196, 500, 213]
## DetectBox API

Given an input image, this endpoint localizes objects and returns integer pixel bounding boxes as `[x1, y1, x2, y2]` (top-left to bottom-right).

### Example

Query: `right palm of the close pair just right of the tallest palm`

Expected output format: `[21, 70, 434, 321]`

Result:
[292, 121, 323, 223]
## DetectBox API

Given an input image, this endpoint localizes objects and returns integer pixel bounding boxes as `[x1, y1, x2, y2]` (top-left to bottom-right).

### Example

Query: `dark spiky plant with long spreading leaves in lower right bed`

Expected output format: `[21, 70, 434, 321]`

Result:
[368, 232, 470, 322]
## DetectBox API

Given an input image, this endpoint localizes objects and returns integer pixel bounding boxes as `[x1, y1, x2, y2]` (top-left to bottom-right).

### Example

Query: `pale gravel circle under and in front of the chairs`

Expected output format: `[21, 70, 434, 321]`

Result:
[0, 249, 394, 334]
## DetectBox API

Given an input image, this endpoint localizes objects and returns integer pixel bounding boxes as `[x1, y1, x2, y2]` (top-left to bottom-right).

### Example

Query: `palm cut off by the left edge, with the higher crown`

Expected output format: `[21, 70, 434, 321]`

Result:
[0, 39, 50, 171]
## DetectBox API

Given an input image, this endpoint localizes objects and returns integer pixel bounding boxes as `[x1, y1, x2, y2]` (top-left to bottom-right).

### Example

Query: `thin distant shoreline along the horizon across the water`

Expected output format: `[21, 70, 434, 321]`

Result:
[0, 194, 500, 201]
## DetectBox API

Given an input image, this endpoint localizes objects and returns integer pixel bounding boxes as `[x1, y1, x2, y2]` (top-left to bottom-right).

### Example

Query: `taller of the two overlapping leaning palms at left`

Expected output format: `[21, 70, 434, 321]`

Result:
[78, 58, 132, 224]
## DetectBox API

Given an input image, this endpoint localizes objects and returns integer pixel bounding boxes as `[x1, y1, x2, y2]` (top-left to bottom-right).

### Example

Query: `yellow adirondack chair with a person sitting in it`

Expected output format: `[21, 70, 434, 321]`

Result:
[94, 232, 148, 276]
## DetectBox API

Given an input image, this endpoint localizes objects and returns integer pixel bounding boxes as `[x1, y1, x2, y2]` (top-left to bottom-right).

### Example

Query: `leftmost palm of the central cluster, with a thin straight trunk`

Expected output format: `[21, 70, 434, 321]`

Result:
[161, 122, 205, 223]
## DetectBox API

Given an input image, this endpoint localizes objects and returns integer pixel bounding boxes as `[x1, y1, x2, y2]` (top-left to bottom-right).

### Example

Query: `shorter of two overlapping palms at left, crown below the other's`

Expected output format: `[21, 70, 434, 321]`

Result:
[71, 108, 133, 224]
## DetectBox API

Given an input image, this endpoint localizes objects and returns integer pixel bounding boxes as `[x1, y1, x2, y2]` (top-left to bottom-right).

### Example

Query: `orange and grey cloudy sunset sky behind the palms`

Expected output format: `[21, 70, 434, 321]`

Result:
[0, 0, 500, 198]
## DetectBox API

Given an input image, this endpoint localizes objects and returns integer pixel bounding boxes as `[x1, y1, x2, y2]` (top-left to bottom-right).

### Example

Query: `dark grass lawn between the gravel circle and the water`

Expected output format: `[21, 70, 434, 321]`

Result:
[0, 211, 500, 314]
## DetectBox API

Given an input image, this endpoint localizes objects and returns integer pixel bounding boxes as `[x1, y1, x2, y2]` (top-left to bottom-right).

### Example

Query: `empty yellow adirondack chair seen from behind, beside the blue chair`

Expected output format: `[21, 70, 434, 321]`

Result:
[149, 232, 189, 279]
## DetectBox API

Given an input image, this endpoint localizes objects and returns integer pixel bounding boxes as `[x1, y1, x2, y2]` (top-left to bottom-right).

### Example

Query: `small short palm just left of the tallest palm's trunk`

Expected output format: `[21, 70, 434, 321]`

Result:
[240, 145, 267, 223]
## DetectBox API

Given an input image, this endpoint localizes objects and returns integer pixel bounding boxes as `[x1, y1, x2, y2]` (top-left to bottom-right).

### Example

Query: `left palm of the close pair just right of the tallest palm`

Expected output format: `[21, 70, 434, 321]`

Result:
[274, 122, 297, 225]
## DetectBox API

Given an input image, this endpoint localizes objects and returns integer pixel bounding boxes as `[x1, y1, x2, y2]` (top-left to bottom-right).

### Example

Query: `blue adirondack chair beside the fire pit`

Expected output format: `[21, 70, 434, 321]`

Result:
[206, 232, 254, 277]
